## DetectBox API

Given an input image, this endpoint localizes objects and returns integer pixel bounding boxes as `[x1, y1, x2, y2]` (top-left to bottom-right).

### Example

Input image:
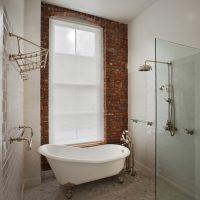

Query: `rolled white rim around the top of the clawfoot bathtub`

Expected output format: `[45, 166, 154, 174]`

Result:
[38, 144, 130, 164]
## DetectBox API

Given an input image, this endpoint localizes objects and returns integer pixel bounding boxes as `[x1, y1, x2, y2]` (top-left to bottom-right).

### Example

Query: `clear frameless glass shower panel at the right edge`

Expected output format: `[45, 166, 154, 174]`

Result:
[156, 39, 200, 200]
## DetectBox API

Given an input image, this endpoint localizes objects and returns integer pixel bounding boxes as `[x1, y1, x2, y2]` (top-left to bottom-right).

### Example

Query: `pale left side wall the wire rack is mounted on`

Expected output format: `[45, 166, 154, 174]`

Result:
[0, 0, 24, 200]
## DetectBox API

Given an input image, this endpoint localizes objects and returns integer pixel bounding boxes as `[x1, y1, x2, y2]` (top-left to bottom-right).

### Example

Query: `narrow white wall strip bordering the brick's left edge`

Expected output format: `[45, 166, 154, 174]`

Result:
[24, 0, 41, 187]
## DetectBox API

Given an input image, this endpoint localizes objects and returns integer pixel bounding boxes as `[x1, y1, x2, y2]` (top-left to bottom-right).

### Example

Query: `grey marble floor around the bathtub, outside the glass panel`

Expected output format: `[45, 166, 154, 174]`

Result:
[24, 172, 155, 200]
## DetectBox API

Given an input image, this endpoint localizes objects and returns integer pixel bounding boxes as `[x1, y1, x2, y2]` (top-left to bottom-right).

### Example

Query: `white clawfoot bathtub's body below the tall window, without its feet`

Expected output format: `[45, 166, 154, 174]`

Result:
[38, 144, 130, 185]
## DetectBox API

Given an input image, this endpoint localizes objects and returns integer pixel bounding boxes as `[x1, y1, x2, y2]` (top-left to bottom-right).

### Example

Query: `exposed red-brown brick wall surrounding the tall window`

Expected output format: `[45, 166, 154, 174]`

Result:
[41, 3, 128, 170]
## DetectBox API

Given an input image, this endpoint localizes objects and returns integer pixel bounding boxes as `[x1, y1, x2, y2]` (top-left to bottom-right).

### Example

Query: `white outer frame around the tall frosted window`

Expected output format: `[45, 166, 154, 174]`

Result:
[49, 18, 105, 145]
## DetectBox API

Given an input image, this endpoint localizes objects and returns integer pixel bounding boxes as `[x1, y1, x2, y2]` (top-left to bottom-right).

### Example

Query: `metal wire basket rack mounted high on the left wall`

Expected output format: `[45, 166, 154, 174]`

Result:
[9, 33, 49, 80]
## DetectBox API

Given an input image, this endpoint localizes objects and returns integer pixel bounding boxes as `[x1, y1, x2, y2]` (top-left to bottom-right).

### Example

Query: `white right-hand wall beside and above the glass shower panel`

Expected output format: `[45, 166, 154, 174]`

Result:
[129, 0, 200, 197]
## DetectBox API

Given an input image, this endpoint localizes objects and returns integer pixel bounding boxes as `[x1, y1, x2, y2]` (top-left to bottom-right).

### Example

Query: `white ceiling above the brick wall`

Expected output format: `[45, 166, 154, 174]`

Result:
[43, 0, 156, 23]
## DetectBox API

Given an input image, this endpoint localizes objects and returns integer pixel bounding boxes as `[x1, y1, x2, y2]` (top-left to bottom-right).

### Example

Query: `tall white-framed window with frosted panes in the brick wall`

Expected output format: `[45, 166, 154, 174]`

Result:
[49, 20, 104, 144]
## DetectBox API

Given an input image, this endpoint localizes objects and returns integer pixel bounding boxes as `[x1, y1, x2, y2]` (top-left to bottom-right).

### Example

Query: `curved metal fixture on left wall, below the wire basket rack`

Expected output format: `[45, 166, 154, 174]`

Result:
[10, 126, 33, 151]
